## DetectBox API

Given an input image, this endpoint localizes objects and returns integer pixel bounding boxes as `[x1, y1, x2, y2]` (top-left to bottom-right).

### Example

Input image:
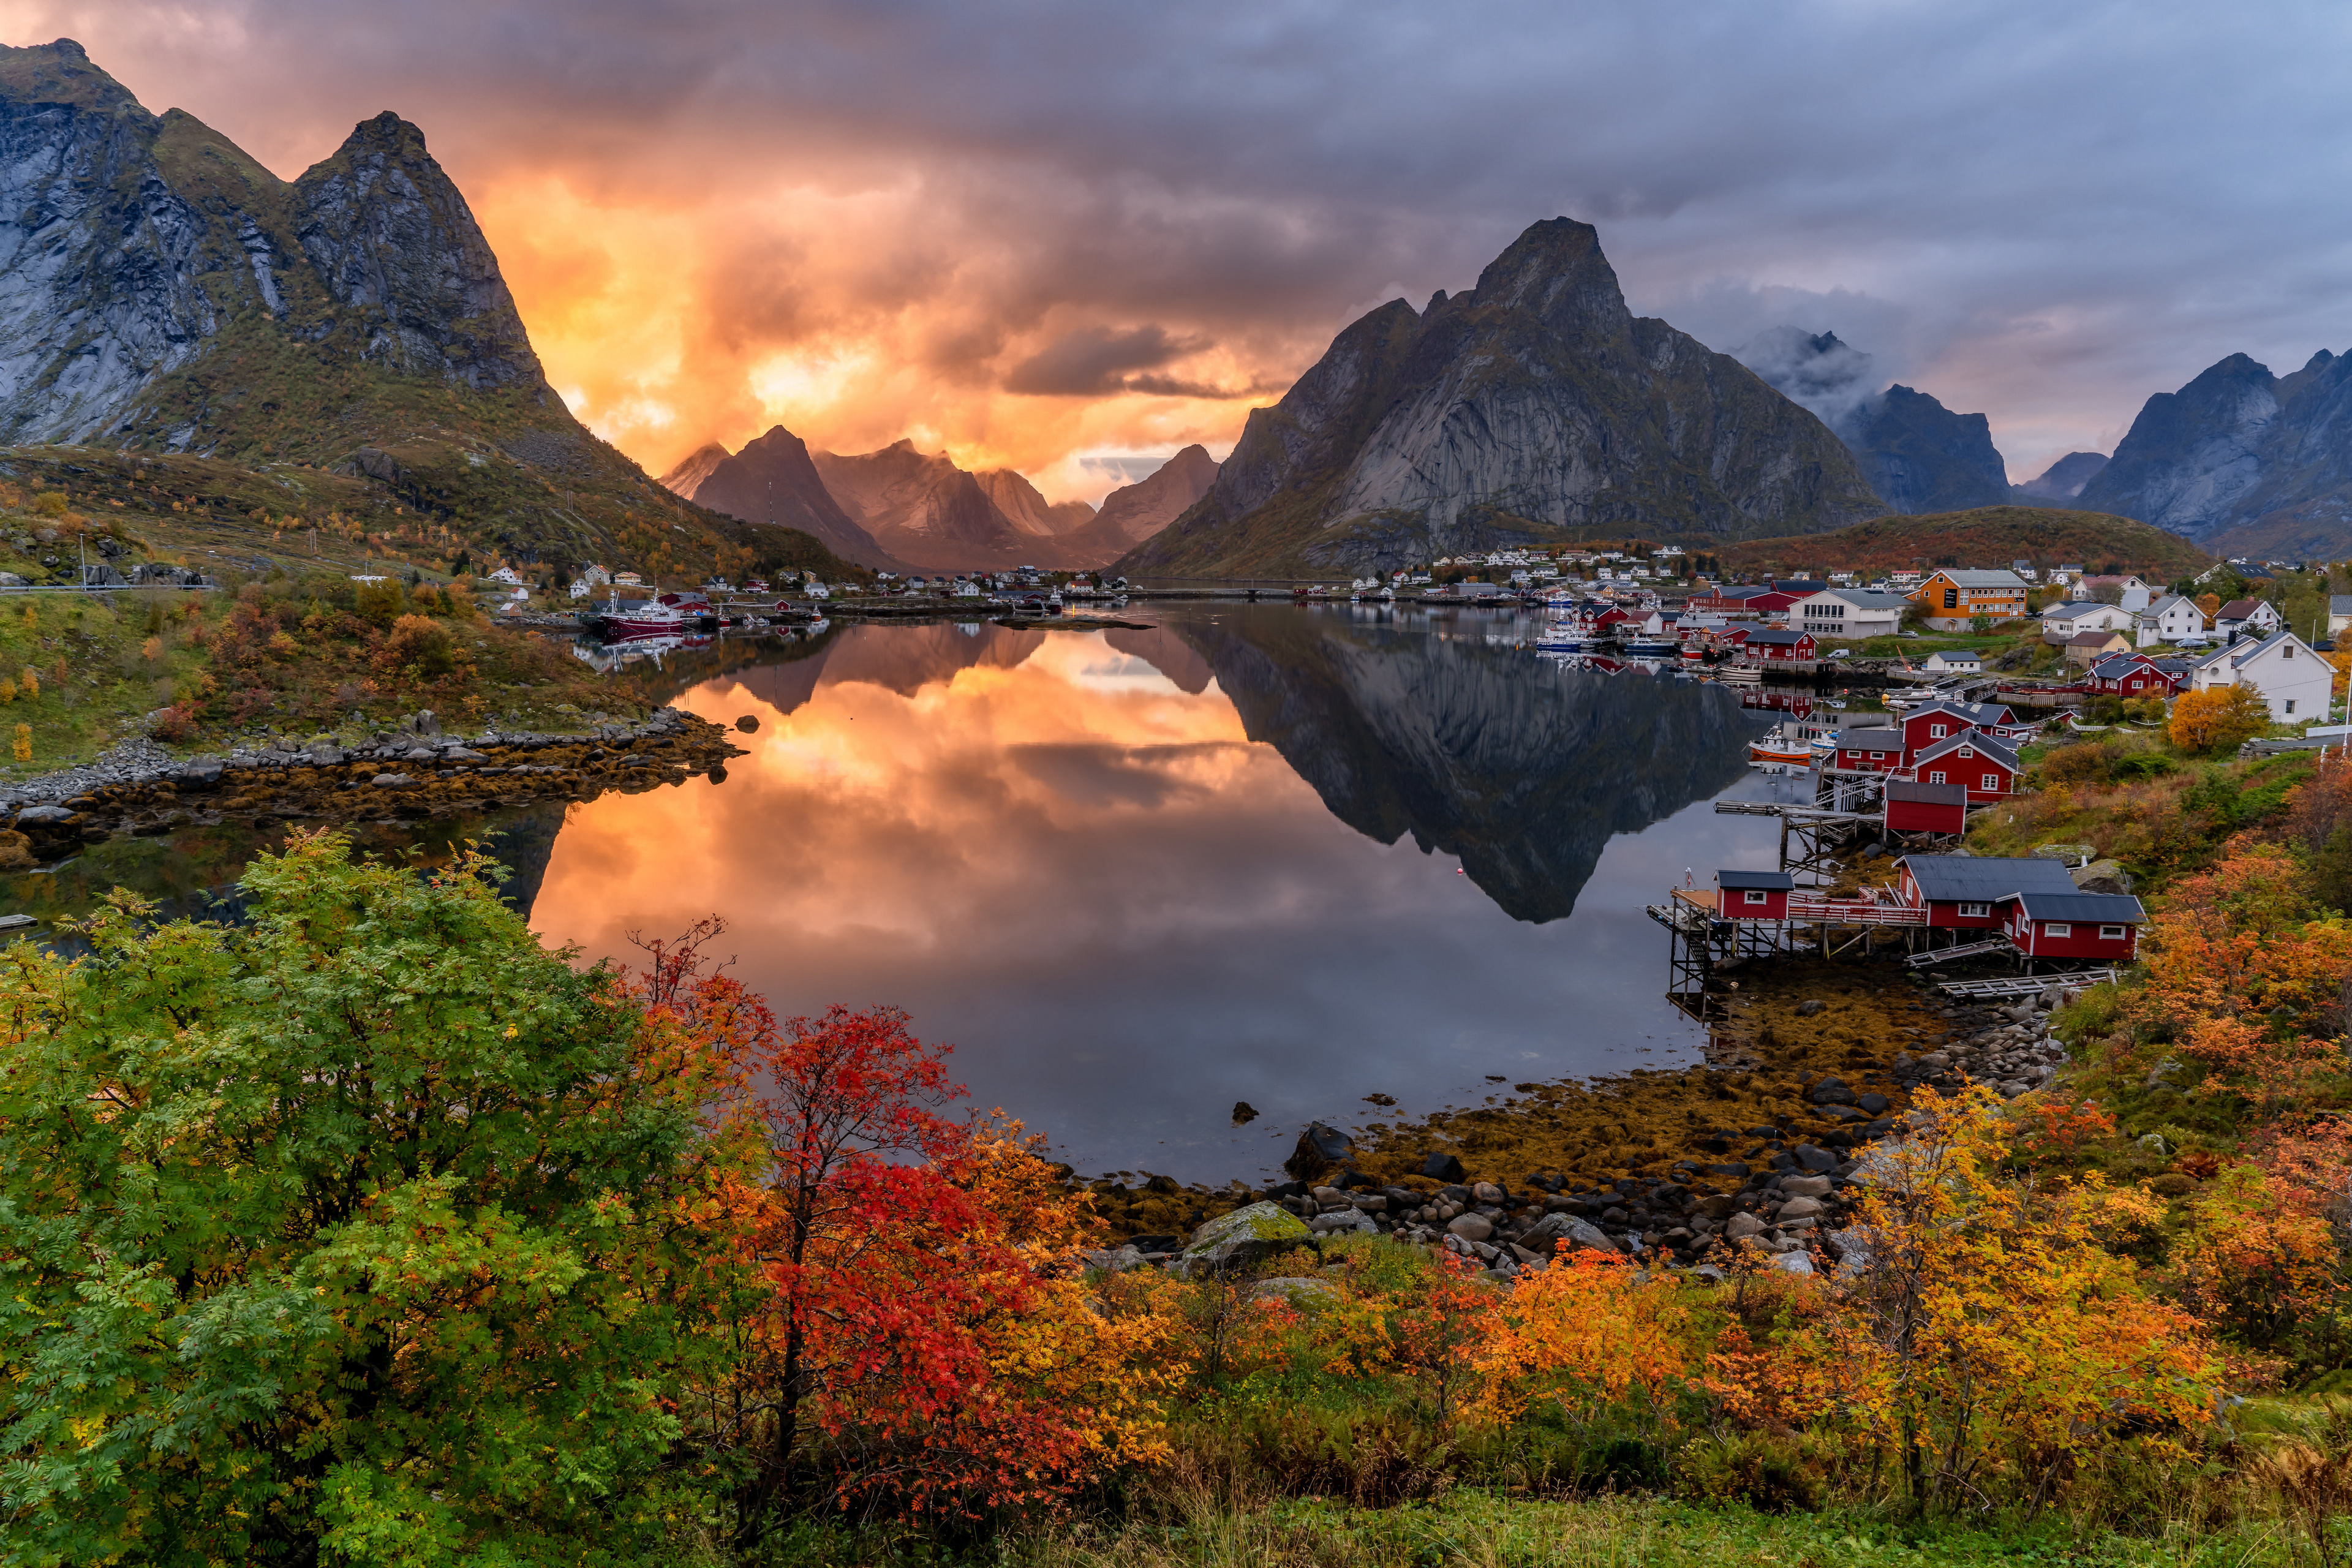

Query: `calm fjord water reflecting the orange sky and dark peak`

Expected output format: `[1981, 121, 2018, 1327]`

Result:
[532, 606, 1776, 1183]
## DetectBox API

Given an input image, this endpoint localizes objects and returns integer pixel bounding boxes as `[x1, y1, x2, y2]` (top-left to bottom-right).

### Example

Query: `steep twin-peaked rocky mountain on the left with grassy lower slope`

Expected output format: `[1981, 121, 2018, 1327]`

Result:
[0, 37, 840, 587]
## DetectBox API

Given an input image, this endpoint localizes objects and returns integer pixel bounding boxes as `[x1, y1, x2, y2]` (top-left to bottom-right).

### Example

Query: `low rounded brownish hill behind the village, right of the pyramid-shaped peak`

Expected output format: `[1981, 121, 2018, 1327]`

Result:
[1719, 505, 2213, 583]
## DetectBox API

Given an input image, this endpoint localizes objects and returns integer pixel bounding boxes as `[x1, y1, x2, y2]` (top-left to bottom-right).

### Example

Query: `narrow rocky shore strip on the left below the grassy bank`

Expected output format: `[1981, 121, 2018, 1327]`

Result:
[0, 707, 743, 870]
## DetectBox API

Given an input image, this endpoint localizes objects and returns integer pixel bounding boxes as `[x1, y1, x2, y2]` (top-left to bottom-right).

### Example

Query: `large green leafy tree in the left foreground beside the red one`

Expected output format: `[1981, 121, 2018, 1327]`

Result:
[0, 837, 724, 1566]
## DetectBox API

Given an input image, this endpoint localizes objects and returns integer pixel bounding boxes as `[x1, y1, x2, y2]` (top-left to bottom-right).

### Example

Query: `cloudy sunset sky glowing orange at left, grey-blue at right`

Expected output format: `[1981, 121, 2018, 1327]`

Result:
[0, 0, 2352, 501]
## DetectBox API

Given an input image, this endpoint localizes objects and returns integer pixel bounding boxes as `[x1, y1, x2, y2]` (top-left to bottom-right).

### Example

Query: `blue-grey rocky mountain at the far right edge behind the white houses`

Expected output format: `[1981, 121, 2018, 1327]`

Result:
[2079, 350, 2352, 557]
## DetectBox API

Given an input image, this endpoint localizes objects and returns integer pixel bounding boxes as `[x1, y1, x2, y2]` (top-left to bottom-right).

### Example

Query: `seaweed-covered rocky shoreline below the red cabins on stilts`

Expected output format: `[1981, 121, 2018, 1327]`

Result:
[1072, 959, 2067, 1276]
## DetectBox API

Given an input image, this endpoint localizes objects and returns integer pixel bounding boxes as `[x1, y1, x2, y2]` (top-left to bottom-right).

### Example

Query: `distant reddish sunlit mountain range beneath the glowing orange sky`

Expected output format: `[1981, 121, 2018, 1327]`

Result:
[661, 426, 1216, 571]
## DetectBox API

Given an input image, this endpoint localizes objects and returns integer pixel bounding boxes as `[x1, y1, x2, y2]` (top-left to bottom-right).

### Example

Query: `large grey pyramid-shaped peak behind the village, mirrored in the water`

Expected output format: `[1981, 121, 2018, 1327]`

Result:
[1120, 219, 1884, 576]
